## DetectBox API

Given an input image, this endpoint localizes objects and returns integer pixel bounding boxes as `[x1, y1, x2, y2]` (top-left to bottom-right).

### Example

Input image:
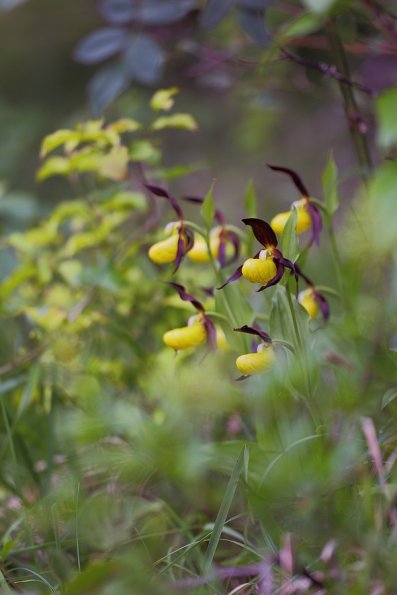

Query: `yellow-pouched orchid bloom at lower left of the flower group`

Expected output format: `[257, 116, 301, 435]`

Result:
[163, 283, 217, 351]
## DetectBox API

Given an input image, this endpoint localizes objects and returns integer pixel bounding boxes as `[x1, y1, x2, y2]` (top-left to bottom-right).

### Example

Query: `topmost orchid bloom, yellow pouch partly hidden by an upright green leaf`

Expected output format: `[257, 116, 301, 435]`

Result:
[268, 165, 322, 244]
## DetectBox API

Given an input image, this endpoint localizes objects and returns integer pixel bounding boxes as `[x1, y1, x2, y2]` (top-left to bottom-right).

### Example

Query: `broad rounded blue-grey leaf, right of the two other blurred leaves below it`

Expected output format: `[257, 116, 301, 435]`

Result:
[123, 34, 164, 85]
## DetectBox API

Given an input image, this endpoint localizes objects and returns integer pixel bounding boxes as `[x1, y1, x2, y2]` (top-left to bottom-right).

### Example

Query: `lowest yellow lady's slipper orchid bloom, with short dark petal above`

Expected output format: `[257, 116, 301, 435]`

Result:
[234, 325, 276, 380]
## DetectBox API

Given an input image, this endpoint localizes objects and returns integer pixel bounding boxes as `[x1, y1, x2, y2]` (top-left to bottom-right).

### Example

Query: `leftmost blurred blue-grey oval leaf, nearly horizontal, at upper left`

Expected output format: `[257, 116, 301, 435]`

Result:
[73, 27, 128, 64]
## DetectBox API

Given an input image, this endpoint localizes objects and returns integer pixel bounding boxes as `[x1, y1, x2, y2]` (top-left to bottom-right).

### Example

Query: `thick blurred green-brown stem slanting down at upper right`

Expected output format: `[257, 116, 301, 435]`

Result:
[327, 20, 372, 184]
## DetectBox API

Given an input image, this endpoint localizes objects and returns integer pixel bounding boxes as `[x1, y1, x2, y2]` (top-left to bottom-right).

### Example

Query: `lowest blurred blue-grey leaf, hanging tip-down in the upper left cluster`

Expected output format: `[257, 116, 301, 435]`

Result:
[88, 65, 130, 116]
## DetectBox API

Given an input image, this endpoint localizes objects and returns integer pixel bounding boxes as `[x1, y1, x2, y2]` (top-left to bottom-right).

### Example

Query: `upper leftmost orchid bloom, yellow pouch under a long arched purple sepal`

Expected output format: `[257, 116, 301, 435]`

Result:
[145, 184, 194, 273]
